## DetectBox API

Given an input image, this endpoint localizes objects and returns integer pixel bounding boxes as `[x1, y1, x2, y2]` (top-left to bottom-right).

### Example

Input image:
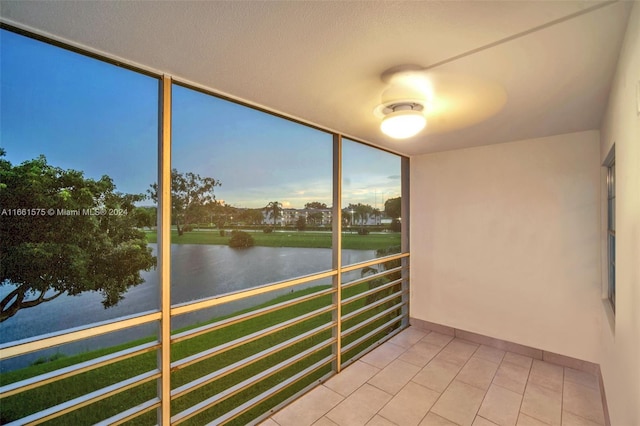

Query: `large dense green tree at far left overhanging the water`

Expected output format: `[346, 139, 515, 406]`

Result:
[0, 149, 156, 322]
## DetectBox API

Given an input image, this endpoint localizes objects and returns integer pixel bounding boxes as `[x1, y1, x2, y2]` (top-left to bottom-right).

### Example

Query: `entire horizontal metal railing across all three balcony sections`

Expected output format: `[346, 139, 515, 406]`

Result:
[0, 253, 409, 425]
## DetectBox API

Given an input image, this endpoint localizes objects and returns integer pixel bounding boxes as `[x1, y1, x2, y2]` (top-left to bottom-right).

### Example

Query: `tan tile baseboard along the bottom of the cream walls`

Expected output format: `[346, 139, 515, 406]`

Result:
[409, 318, 611, 426]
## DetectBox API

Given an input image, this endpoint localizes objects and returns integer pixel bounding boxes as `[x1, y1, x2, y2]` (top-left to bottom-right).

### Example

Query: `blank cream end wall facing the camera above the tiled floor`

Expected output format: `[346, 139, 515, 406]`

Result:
[411, 131, 602, 362]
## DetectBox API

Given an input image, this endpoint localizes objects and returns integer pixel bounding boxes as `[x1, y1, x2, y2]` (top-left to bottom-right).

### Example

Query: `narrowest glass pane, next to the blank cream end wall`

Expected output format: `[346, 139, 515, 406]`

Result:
[342, 139, 402, 265]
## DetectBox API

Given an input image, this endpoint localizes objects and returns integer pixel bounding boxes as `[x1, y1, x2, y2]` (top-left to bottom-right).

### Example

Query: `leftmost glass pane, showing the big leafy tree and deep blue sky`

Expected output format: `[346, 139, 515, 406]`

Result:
[0, 30, 159, 344]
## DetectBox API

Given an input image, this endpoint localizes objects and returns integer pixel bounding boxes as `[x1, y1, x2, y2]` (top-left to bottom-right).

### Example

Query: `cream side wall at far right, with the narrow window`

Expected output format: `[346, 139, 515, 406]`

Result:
[600, 3, 640, 426]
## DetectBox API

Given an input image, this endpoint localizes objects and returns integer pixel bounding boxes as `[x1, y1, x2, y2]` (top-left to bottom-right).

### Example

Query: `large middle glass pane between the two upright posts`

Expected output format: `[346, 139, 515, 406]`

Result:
[171, 85, 333, 304]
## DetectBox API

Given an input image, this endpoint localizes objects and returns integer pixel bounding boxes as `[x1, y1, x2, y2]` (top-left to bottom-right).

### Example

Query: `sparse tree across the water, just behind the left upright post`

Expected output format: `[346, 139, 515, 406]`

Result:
[147, 169, 221, 236]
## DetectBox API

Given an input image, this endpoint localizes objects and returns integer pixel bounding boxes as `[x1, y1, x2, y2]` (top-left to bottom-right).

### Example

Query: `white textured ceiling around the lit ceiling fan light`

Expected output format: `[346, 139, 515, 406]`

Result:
[0, 0, 632, 155]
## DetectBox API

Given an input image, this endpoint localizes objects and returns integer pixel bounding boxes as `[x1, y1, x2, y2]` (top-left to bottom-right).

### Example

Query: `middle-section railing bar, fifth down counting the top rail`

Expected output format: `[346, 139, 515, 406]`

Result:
[171, 338, 334, 424]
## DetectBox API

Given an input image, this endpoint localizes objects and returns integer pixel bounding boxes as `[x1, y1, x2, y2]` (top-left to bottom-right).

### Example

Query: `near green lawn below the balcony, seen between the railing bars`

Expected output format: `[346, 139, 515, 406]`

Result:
[0, 274, 397, 425]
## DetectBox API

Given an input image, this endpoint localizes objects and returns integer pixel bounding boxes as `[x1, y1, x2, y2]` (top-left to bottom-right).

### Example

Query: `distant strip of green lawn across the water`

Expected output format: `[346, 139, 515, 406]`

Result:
[146, 230, 400, 250]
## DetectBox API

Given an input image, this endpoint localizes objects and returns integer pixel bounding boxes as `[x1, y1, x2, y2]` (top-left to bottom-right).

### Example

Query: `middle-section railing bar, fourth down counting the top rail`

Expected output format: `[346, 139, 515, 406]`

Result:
[171, 322, 334, 399]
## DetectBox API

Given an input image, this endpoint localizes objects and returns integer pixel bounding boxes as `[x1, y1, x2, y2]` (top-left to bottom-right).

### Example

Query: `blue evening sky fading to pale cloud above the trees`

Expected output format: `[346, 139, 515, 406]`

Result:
[0, 31, 400, 208]
